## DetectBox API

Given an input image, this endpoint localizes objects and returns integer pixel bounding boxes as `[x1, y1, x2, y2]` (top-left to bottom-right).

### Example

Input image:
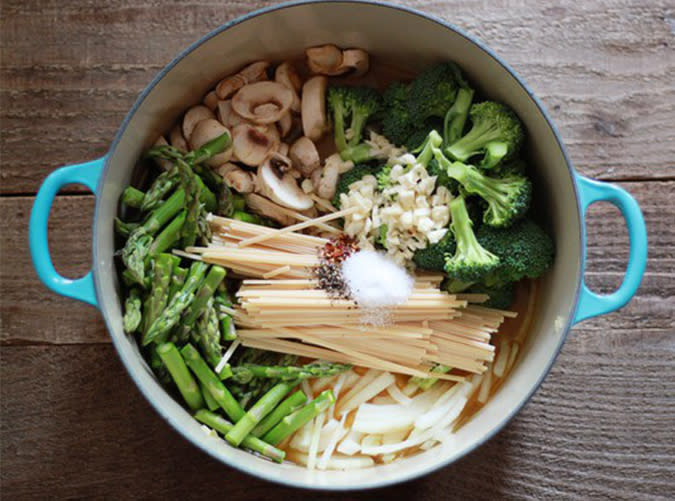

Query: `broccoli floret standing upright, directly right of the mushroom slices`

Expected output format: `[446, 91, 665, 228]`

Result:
[328, 87, 382, 163]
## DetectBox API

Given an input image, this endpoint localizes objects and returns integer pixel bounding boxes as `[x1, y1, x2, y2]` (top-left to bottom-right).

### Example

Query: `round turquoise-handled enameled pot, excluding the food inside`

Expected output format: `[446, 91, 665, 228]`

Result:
[30, 1, 647, 490]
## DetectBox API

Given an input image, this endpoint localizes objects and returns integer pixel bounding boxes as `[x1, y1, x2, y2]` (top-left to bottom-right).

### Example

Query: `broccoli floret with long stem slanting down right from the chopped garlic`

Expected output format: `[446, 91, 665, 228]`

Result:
[434, 149, 532, 228]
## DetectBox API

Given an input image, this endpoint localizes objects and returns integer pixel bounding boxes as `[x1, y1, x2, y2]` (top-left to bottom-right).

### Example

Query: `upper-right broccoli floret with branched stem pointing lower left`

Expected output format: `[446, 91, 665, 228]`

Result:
[445, 101, 524, 169]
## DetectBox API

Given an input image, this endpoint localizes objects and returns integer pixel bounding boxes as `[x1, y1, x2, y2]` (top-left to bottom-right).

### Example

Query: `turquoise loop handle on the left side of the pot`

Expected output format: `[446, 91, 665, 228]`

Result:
[28, 157, 106, 306]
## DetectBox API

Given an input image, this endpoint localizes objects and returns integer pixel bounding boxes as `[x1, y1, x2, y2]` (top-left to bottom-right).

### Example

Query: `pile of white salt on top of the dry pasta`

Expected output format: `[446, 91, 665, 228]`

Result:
[342, 250, 415, 324]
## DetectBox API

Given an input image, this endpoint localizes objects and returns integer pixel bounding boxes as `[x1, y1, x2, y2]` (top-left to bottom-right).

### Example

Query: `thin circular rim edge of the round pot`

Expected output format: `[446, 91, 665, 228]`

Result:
[93, 0, 586, 491]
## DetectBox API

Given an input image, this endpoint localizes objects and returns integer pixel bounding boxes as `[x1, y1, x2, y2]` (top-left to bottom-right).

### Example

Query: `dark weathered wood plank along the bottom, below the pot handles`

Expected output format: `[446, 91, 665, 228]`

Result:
[0, 344, 675, 500]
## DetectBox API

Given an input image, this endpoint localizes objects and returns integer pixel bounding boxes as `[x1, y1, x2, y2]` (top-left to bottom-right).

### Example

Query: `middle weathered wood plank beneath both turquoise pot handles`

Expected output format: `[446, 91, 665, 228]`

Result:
[0, 182, 675, 344]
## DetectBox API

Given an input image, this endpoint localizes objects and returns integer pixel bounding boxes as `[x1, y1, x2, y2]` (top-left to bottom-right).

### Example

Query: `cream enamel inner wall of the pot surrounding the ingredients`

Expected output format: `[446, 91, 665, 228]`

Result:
[94, 2, 582, 489]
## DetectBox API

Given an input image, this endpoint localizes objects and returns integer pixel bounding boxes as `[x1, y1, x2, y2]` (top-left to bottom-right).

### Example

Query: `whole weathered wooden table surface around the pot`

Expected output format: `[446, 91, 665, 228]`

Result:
[0, 0, 675, 500]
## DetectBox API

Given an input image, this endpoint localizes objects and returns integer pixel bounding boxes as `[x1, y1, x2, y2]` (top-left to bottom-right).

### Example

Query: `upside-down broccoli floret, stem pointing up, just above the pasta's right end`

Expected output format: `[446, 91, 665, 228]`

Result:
[444, 196, 499, 282]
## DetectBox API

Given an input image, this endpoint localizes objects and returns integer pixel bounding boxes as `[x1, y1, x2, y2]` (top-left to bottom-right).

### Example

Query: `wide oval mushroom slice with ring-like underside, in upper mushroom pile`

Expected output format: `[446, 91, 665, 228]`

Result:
[232, 82, 293, 124]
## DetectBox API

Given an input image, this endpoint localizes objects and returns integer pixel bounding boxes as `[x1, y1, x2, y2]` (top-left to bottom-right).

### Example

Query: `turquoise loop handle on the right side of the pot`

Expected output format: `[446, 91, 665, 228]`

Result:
[574, 174, 647, 323]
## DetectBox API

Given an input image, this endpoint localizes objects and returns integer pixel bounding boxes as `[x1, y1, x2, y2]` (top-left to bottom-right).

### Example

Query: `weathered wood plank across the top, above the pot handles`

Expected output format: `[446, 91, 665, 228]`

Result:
[0, 0, 675, 193]
